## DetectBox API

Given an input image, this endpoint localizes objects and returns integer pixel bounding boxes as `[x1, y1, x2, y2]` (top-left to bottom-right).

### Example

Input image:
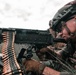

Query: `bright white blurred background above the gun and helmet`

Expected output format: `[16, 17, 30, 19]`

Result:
[0, 0, 72, 30]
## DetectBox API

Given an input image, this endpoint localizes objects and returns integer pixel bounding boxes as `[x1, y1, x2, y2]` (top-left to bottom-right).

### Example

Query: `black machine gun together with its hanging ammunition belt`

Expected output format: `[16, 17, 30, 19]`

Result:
[0, 28, 66, 75]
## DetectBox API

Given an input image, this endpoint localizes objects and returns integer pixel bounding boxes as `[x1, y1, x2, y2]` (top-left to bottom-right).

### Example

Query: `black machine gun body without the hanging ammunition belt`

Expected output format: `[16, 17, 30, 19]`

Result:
[0, 28, 66, 48]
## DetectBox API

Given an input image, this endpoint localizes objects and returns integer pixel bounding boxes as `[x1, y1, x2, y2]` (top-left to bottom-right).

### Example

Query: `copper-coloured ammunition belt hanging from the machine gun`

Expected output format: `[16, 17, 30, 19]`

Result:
[2, 31, 22, 75]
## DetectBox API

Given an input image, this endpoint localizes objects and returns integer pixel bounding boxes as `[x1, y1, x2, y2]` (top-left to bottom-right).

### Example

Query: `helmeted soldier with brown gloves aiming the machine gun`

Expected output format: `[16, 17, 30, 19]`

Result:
[24, 1, 76, 75]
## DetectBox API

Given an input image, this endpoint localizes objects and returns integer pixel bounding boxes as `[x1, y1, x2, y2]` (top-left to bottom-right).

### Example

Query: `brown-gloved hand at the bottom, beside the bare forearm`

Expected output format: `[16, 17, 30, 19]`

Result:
[23, 59, 45, 75]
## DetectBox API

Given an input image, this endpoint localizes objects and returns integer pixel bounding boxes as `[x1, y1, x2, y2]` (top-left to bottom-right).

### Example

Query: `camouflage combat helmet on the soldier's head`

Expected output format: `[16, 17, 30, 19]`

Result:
[49, 0, 76, 32]
